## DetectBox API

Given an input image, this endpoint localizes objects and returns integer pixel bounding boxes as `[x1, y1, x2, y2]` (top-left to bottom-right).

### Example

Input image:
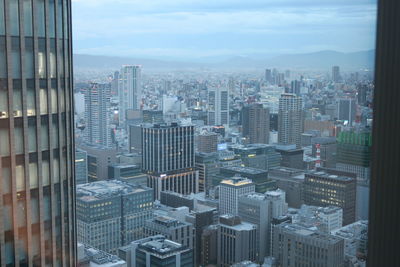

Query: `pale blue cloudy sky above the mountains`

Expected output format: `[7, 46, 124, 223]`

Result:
[72, 0, 377, 59]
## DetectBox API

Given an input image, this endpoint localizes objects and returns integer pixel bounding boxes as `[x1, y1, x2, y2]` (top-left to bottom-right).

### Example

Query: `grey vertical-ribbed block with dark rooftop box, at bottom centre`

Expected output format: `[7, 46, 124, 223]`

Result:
[217, 215, 258, 267]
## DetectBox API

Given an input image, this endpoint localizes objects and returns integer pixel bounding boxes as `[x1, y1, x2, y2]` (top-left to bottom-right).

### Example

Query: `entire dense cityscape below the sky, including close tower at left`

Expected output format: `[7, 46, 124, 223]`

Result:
[0, 0, 375, 267]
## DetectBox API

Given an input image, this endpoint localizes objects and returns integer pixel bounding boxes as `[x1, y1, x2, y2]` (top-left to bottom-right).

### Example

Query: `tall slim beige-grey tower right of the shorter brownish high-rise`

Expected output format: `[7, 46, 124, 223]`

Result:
[278, 94, 303, 148]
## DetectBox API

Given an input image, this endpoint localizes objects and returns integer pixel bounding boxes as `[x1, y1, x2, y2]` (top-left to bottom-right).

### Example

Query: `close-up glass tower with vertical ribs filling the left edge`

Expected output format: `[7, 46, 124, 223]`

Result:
[0, 0, 76, 266]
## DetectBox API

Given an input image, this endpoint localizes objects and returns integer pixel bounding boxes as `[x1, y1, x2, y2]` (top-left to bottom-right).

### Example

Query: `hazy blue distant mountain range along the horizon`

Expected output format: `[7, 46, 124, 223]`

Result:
[74, 50, 375, 71]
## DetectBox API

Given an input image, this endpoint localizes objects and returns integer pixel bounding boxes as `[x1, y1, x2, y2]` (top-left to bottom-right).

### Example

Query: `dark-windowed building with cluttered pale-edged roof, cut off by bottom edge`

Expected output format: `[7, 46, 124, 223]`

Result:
[118, 235, 194, 267]
